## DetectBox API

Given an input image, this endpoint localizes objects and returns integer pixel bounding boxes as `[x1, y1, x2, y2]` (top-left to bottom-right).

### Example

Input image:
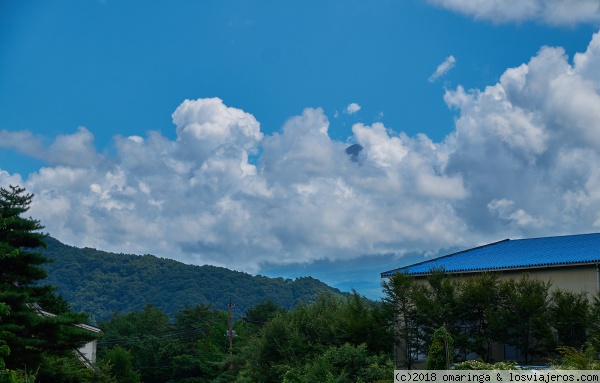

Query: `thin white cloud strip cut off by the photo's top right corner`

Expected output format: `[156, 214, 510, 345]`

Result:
[429, 0, 600, 25]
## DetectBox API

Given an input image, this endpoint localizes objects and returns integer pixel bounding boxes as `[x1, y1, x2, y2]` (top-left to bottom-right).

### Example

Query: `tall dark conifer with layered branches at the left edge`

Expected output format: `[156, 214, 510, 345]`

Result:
[0, 186, 95, 370]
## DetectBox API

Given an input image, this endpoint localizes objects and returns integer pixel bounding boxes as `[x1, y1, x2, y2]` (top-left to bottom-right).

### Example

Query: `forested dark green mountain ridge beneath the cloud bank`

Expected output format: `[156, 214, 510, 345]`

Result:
[42, 237, 342, 321]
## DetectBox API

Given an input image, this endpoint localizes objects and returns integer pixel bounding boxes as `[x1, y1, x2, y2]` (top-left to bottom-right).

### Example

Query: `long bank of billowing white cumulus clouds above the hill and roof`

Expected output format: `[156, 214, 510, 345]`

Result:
[0, 34, 600, 272]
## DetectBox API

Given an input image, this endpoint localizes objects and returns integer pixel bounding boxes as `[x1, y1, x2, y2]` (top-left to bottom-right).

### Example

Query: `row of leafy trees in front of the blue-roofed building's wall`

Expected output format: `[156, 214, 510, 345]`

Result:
[384, 270, 600, 368]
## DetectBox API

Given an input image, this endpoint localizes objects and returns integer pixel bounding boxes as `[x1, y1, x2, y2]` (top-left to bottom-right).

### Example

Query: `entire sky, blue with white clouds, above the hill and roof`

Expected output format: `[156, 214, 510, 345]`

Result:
[0, 0, 600, 300]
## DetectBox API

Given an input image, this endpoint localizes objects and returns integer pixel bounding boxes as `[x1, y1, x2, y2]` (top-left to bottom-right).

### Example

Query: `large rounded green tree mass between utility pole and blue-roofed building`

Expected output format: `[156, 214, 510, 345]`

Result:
[237, 293, 393, 383]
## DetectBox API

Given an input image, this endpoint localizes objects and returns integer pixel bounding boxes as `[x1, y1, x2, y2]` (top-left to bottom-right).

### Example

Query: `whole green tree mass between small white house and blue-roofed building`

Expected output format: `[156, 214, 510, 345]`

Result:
[99, 293, 394, 383]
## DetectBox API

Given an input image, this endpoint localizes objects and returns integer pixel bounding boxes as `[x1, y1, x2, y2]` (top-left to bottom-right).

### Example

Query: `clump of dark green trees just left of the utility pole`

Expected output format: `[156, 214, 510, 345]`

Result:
[98, 304, 232, 383]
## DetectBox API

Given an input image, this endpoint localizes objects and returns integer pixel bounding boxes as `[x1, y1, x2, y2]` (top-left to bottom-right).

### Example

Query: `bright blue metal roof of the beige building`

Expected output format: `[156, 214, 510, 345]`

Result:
[381, 233, 600, 278]
